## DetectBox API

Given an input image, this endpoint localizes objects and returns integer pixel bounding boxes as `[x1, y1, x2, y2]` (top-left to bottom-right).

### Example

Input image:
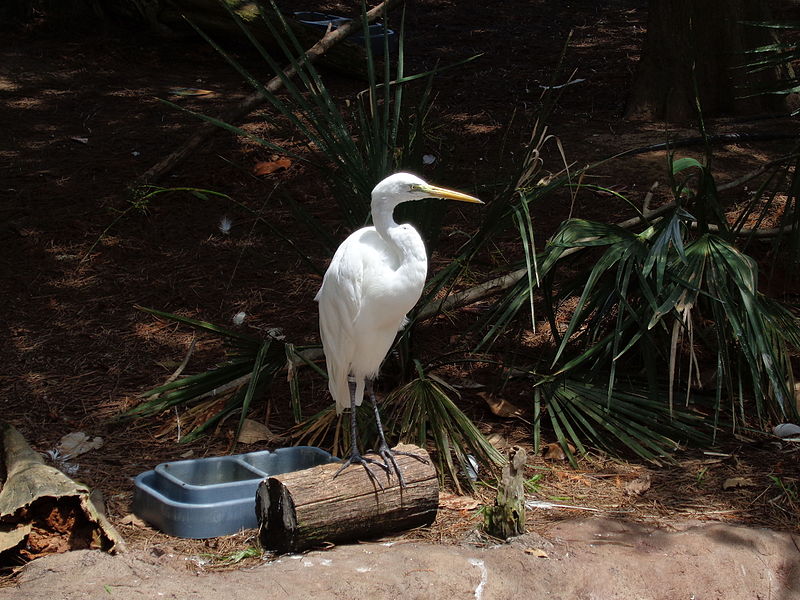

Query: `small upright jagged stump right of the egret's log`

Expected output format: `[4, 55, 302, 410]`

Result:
[484, 446, 527, 540]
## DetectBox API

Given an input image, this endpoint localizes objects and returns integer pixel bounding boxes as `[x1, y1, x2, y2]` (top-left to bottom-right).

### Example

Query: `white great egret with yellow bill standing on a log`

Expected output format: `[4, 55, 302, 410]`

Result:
[315, 173, 483, 487]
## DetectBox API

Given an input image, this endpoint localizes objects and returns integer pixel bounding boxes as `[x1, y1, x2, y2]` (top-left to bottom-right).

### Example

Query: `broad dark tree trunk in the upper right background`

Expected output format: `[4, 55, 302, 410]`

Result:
[626, 0, 785, 122]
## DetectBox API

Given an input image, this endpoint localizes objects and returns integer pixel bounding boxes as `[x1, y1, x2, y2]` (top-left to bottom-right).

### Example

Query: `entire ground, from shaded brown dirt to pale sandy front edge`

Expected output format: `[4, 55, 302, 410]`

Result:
[0, 0, 800, 600]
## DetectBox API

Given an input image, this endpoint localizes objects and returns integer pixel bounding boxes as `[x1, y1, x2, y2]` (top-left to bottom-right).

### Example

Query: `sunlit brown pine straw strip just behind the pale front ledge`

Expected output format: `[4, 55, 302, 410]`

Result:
[89, 426, 800, 571]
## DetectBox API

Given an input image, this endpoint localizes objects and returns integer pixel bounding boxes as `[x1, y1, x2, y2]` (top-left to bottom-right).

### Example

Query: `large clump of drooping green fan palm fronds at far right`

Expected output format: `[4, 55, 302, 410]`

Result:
[481, 152, 800, 461]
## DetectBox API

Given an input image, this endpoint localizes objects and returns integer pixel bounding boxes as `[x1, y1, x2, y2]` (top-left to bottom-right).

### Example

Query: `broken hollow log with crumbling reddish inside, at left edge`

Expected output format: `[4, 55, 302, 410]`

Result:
[0, 423, 124, 566]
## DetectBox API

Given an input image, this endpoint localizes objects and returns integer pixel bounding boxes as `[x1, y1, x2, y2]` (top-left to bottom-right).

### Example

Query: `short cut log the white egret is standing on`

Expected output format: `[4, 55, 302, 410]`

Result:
[256, 444, 439, 552]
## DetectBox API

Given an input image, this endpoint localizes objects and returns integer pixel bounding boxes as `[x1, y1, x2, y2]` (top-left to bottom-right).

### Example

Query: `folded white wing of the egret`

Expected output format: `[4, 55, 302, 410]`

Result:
[316, 232, 364, 413]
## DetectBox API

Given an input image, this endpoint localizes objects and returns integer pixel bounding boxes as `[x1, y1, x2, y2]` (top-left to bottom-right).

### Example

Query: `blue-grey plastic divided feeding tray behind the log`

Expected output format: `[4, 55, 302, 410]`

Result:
[133, 446, 338, 538]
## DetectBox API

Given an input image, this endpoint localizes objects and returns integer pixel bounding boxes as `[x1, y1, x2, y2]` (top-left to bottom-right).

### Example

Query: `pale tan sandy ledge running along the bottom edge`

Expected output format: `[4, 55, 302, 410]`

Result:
[6, 518, 800, 600]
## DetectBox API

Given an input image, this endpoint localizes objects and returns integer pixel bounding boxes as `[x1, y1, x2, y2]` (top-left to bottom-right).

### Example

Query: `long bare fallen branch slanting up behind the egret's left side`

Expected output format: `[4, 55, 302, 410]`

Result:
[134, 0, 400, 187]
